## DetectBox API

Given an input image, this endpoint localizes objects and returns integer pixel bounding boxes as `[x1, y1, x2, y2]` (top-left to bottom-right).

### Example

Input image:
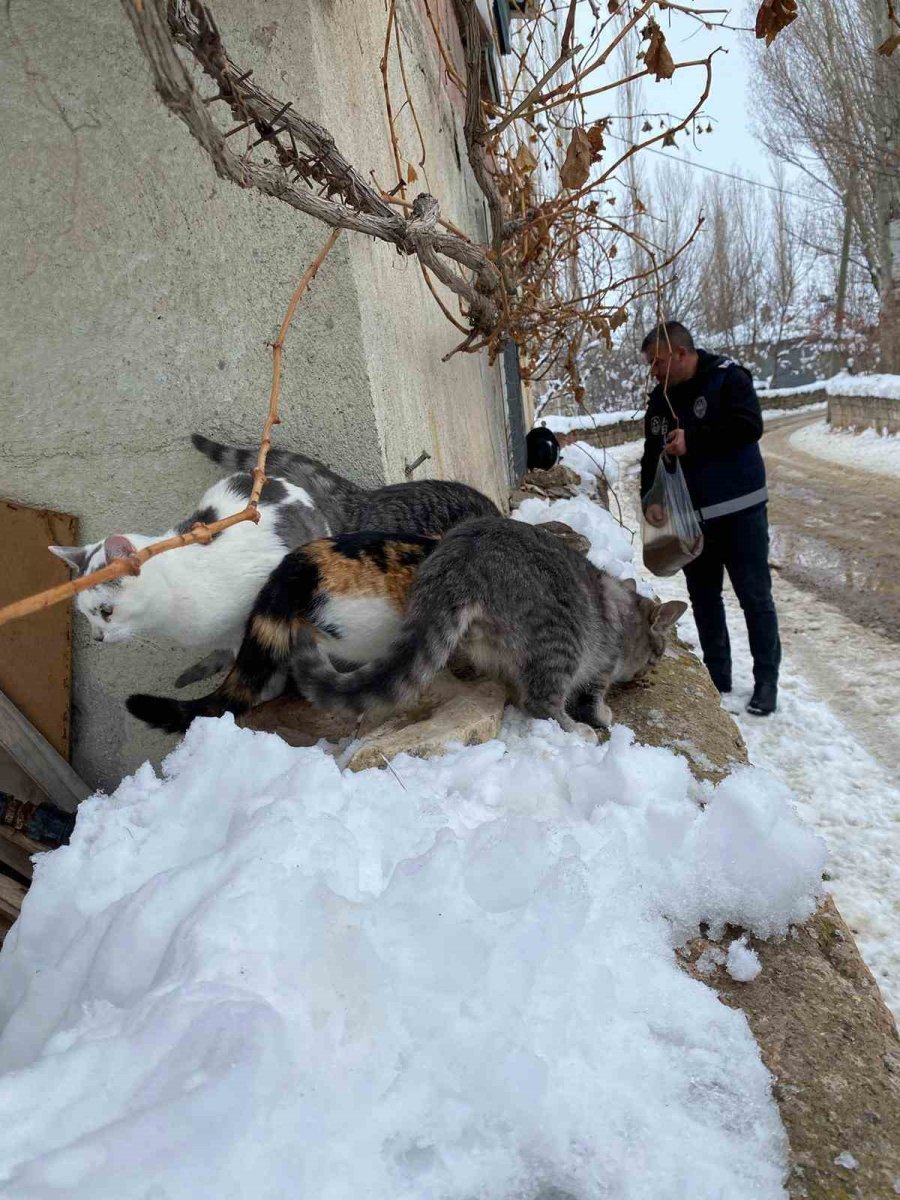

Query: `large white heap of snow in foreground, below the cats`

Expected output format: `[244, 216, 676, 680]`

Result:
[0, 714, 823, 1200]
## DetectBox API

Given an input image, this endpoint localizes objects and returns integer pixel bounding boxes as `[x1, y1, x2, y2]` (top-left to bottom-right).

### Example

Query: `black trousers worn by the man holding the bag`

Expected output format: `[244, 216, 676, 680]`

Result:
[684, 504, 781, 691]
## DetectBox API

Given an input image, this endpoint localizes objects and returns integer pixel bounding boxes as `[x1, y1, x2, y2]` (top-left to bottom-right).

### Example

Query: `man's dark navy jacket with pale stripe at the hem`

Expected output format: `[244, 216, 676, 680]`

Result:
[641, 350, 767, 521]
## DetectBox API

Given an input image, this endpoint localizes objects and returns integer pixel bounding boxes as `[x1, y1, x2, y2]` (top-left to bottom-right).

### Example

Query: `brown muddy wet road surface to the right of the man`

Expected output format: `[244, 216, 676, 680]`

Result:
[762, 415, 900, 642]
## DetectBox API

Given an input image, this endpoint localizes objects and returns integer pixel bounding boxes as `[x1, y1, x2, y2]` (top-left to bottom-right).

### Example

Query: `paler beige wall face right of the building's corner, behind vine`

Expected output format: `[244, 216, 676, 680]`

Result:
[304, 0, 508, 499]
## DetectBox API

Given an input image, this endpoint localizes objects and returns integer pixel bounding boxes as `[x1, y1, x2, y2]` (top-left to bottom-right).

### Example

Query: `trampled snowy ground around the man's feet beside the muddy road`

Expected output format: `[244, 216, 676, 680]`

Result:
[592, 434, 900, 1018]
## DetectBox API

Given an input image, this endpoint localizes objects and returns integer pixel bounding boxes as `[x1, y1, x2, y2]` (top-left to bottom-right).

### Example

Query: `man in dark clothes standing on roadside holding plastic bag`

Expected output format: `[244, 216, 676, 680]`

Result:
[641, 320, 781, 716]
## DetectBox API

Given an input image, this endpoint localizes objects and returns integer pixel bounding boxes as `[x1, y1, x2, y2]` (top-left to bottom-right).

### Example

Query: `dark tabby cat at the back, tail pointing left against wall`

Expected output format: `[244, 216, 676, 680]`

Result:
[191, 433, 500, 534]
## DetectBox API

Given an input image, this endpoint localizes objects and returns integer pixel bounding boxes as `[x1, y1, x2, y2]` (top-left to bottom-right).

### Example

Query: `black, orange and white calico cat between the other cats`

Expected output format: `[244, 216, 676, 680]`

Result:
[127, 532, 438, 733]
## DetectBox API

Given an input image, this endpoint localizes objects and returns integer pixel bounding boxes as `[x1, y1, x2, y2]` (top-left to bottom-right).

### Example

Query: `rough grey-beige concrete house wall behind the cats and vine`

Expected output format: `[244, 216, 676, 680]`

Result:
[0, 0, 508, 787]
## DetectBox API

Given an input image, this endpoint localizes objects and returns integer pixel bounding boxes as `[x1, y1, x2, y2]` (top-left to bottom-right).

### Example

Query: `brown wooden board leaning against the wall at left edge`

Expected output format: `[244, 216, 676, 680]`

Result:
[0, 500, 77, 758]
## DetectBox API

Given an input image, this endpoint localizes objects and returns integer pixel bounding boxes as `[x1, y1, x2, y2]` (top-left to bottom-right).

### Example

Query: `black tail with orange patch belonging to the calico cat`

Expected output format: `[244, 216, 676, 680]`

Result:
[125, 547, 318, 733]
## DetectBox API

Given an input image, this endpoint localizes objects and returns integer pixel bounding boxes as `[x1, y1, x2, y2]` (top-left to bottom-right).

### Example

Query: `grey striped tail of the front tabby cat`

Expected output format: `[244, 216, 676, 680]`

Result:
[293, 596, 469, 713]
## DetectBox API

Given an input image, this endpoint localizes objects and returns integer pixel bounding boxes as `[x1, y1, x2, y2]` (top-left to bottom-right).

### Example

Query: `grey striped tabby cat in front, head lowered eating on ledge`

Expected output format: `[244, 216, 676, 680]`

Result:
[293, 518, 688, 731]
